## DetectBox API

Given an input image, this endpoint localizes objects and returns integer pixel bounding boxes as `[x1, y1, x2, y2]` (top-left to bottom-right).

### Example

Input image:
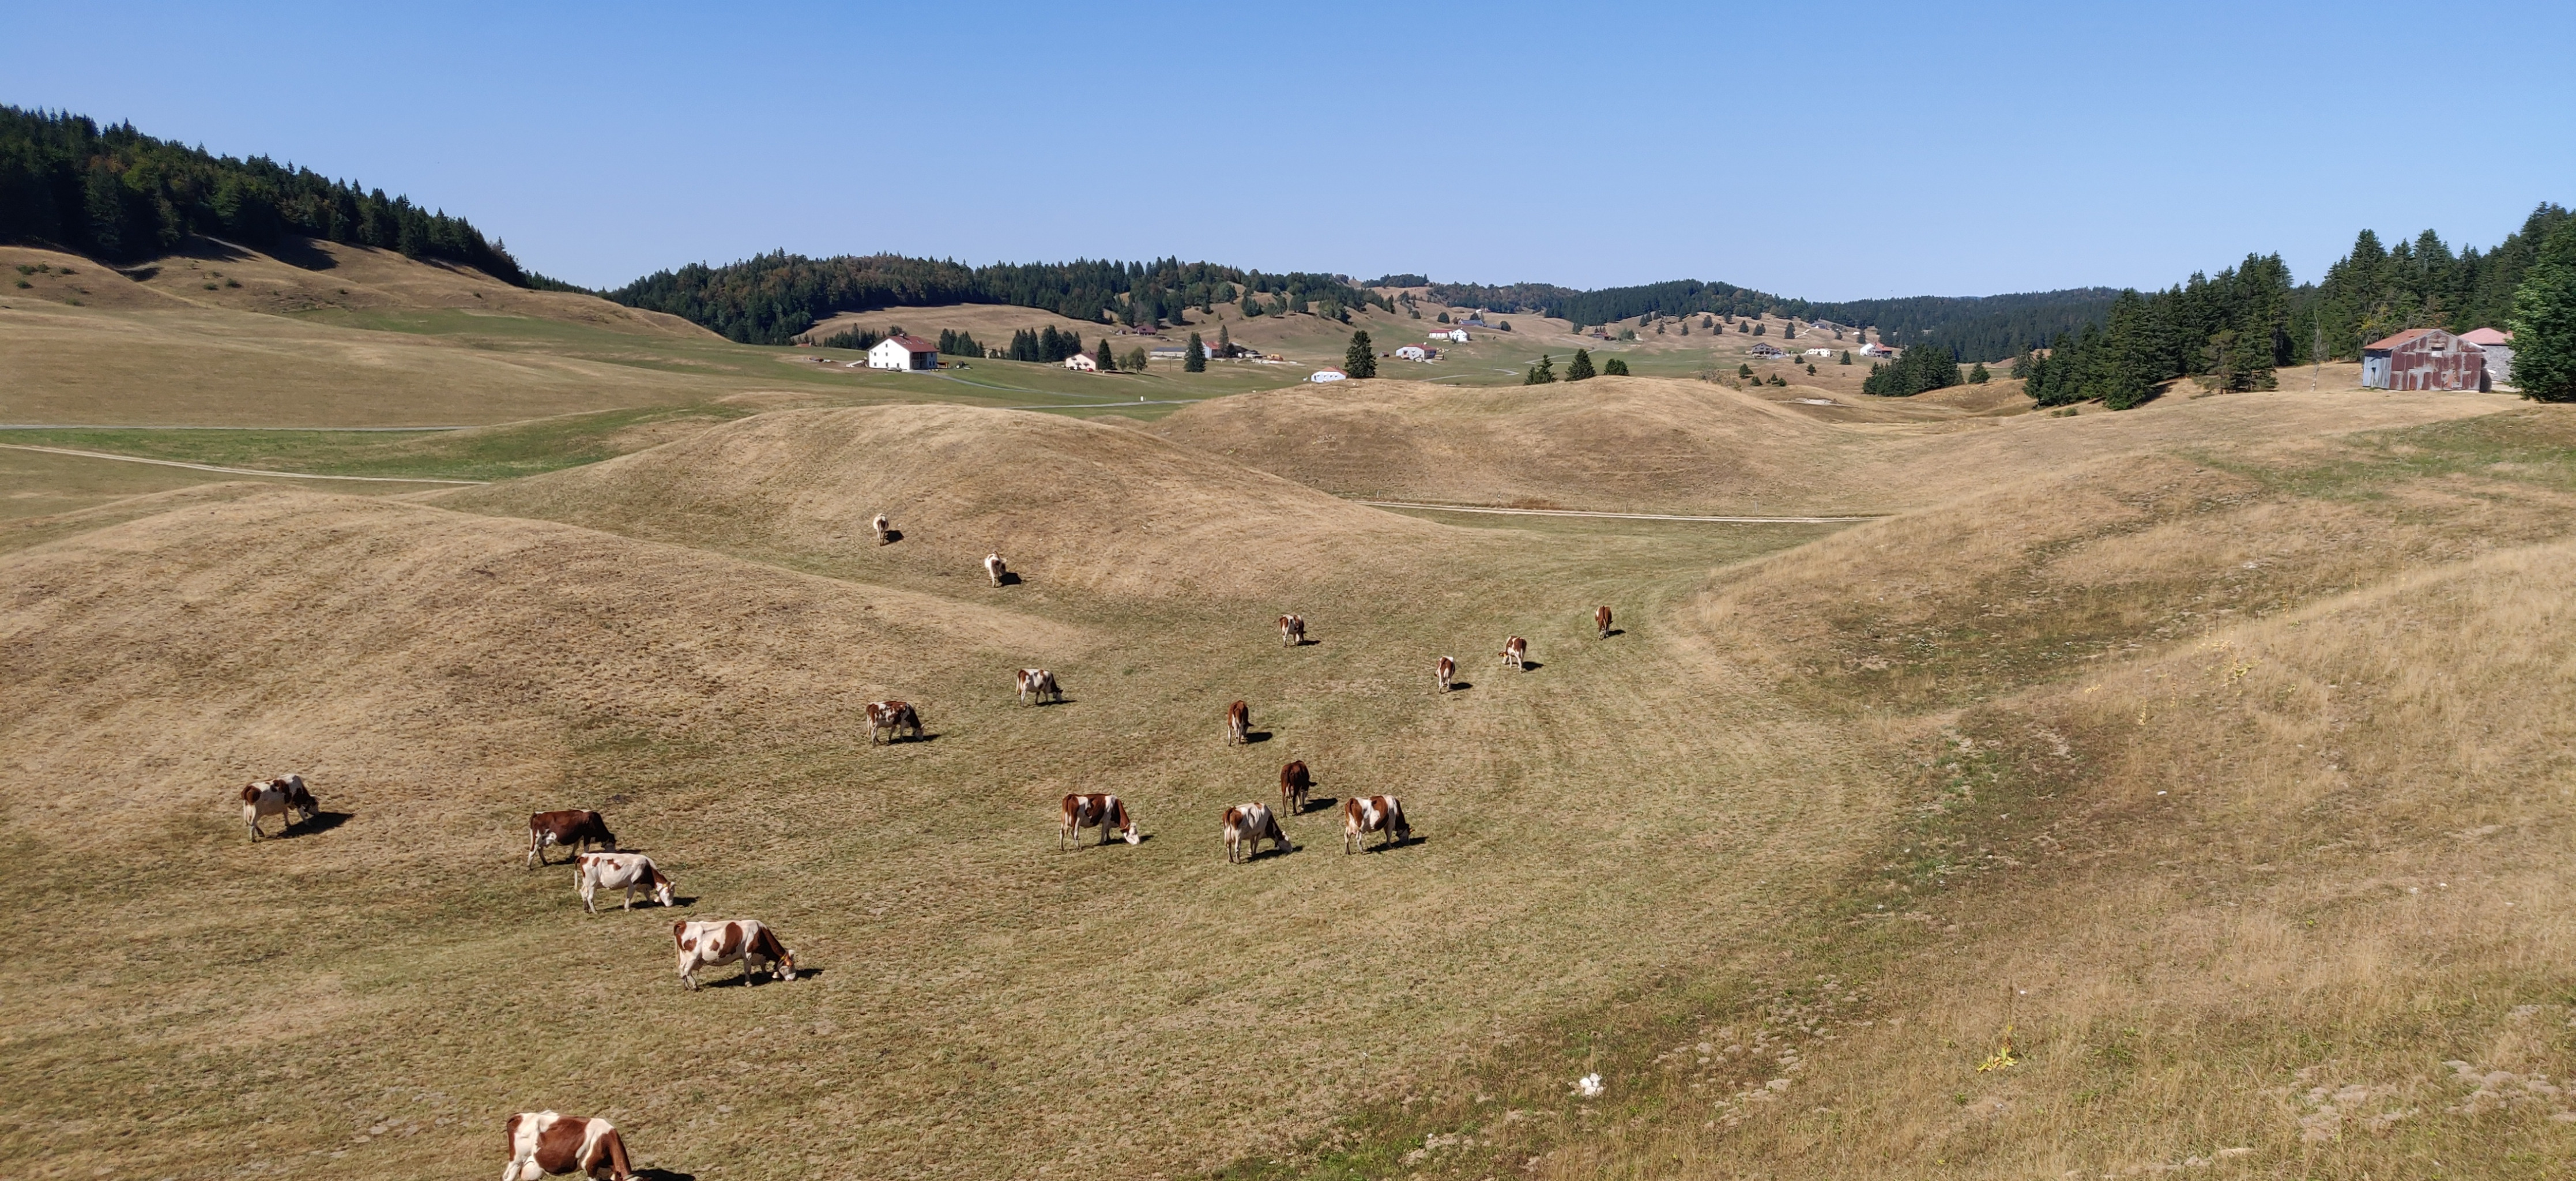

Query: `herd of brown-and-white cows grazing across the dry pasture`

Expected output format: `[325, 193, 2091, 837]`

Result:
[242, 531, 1610, 1181]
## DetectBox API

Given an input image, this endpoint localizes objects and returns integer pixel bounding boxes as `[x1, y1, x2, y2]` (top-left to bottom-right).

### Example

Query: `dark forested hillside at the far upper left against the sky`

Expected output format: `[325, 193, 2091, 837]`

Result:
[0, 106, 548, 286]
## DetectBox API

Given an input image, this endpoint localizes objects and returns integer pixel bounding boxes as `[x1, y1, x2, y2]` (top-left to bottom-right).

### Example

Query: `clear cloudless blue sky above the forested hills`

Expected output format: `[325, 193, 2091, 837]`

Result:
[0, 0, 2576, 299]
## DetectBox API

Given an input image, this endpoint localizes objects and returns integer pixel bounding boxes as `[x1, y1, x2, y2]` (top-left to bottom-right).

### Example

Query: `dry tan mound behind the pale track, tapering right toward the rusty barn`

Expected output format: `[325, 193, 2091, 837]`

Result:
[1151, 377, 2514, 513]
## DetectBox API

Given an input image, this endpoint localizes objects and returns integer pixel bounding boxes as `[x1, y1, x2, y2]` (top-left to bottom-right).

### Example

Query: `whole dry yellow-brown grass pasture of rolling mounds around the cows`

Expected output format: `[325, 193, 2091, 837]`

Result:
[0, 242, 2576, 1181]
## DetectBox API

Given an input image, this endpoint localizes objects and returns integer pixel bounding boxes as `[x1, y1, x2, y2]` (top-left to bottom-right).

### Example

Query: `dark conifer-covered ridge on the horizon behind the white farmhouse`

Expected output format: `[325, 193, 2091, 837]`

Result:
[605, 253, 1388, 345]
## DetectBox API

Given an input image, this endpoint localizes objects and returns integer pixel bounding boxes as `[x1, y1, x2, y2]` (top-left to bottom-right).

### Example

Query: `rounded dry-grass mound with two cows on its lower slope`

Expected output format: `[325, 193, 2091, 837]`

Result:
[443, 405, 1450, 598]
